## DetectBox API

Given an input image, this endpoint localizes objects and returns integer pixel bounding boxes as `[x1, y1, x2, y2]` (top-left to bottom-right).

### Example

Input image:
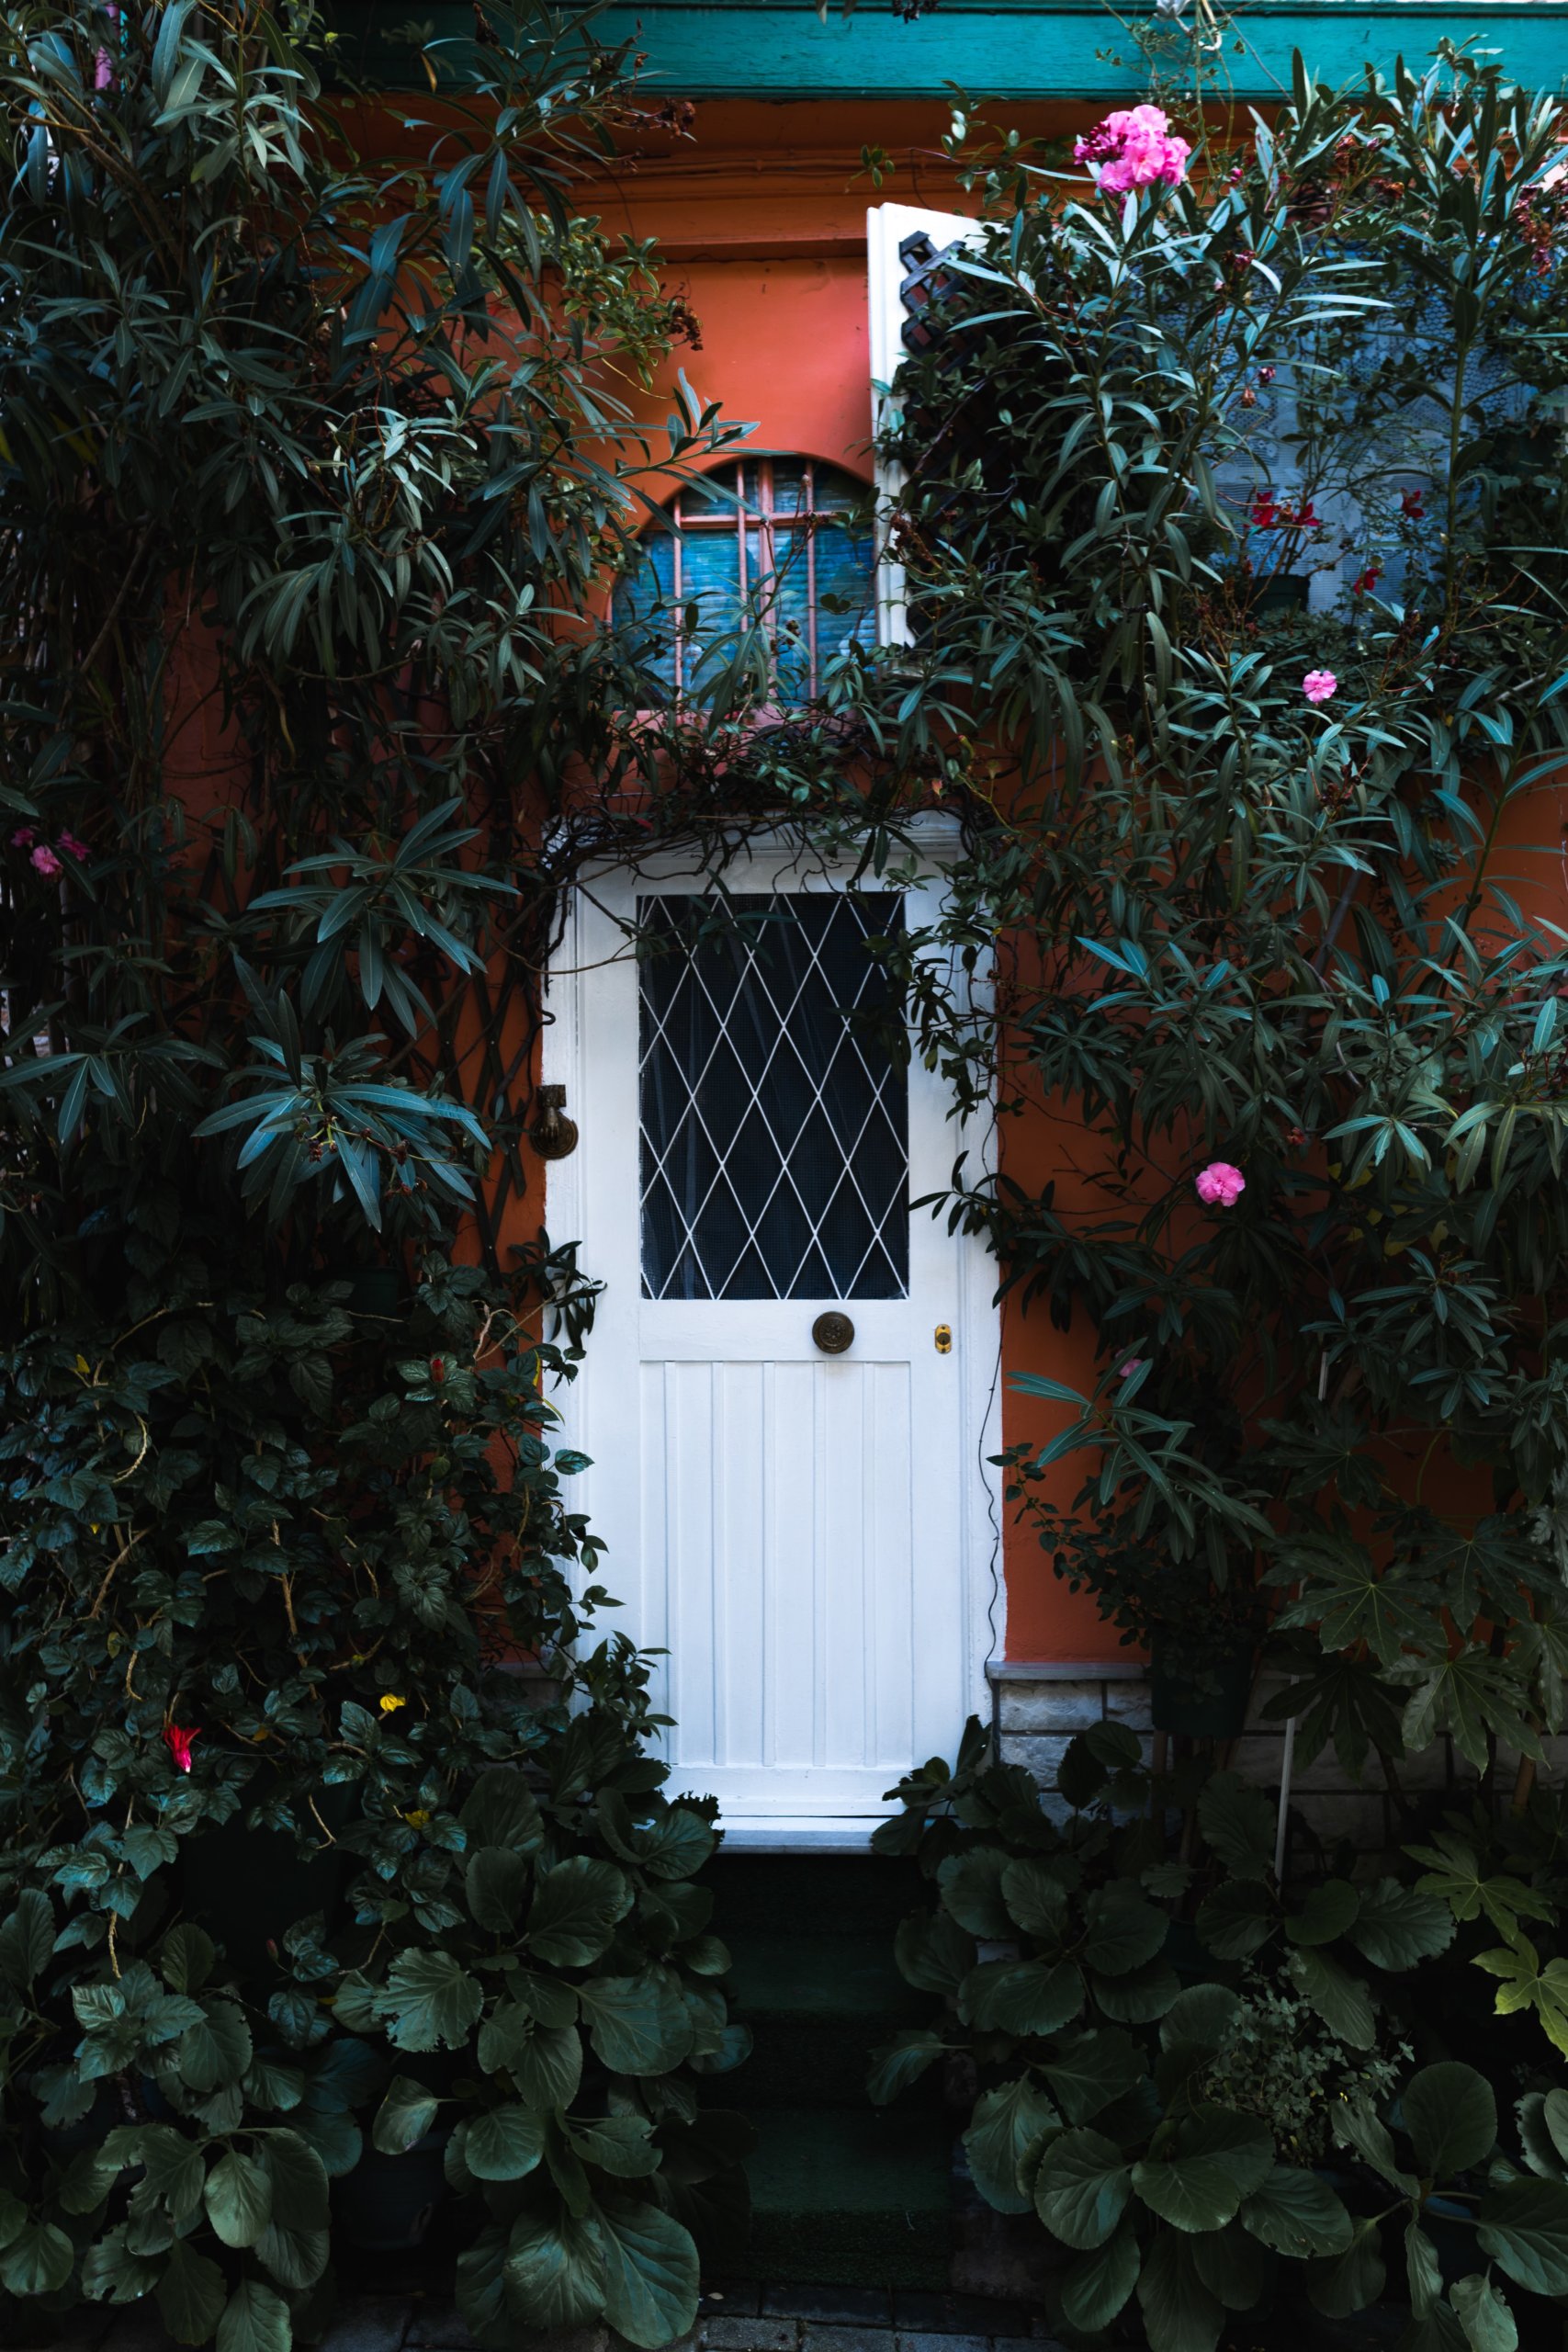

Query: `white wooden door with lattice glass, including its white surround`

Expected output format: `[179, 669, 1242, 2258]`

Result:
[547, 856, 995, 1844]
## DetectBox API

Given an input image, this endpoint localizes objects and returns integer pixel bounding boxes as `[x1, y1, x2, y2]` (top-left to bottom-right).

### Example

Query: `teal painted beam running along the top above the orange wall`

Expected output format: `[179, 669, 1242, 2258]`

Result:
[332, 0, 1568, 99]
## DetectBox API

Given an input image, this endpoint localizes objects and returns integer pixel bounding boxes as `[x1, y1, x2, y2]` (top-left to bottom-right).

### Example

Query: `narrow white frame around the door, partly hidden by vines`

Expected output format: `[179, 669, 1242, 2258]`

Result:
[541, 816, 1006, 1851]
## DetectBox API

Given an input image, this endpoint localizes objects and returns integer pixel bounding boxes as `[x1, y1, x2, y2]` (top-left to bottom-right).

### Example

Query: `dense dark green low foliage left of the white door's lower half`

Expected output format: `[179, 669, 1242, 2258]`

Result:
[0, 1261, 748, 2352]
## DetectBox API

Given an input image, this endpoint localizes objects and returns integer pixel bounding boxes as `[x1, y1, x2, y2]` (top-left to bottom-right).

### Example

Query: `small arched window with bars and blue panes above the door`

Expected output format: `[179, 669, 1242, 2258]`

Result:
[614, 457, 877, 701]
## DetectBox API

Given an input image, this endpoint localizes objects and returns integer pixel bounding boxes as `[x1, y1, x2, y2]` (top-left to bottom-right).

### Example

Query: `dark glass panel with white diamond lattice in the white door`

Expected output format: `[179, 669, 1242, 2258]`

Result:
[637, 891, 909, 1298]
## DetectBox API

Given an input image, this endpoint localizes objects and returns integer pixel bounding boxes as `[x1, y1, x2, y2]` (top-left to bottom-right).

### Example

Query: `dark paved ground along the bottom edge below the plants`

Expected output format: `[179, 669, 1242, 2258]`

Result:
[46, 2286, 1060, 2352]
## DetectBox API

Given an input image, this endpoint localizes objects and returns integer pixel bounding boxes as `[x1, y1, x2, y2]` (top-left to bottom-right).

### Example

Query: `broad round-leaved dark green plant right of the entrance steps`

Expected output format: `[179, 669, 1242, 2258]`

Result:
[872, 1724, 1568, 2352]
